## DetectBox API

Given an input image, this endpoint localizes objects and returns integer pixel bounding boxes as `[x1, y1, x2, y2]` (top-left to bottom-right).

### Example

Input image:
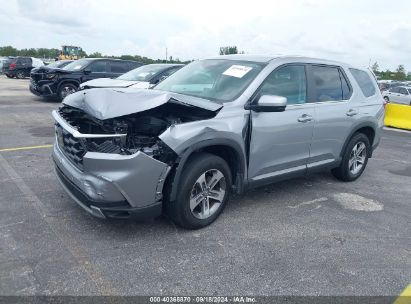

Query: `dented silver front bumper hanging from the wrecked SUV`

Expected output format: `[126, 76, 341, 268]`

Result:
[53, 143, 170, 219]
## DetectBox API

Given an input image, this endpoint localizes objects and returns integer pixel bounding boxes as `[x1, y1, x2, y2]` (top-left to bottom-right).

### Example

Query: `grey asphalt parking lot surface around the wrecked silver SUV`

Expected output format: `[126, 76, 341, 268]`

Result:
[0, 76, 411, 296]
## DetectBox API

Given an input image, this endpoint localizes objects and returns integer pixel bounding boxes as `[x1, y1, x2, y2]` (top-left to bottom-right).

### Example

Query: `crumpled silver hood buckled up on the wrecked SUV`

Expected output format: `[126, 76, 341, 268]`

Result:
[63, 88, 223, 120]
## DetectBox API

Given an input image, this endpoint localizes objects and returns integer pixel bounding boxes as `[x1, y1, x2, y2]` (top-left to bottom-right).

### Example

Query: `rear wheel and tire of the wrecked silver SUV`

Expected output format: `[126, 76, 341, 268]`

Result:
[331, 133, 371, 182]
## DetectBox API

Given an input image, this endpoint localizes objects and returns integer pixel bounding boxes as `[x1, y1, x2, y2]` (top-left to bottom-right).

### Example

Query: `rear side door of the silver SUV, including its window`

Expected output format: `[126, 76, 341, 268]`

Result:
[307, 64, 357, 172]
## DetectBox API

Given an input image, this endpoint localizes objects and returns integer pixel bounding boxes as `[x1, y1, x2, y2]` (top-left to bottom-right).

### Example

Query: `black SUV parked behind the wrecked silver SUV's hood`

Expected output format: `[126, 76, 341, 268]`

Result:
[30, 58, 142, 100]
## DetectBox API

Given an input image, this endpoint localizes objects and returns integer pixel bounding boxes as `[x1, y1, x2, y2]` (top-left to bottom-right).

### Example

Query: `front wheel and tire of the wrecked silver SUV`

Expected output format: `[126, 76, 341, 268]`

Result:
[165, 153, 232, 229]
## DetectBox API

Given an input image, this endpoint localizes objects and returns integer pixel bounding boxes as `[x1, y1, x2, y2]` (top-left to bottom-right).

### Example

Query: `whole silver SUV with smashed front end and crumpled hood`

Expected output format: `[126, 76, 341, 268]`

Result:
[53, 55, 384, 229]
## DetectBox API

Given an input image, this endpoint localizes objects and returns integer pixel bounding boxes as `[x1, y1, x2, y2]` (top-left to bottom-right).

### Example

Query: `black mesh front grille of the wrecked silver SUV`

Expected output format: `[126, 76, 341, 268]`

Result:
[56, 123, 87, 169]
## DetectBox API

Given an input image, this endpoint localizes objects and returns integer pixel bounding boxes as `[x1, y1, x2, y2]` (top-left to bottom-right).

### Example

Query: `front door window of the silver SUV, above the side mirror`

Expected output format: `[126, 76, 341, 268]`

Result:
[260, 65, 307, 104]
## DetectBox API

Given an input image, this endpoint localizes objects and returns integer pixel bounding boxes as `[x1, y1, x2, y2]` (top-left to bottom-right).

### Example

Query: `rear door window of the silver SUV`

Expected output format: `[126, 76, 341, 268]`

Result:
[312, 66, 349, 101]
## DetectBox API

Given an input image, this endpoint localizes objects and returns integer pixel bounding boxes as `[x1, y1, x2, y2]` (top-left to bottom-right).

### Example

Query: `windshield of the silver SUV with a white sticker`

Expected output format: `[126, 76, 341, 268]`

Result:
[155, 59, 265, 102]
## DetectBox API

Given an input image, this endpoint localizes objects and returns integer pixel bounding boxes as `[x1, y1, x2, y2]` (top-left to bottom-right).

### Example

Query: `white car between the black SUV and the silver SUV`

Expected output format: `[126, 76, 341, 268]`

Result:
[80, 64, 184, 90]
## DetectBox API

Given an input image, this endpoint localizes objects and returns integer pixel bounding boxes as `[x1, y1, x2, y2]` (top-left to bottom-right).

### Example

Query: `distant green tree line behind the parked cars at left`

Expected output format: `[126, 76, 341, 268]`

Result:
[0, 46, 190, 64]
